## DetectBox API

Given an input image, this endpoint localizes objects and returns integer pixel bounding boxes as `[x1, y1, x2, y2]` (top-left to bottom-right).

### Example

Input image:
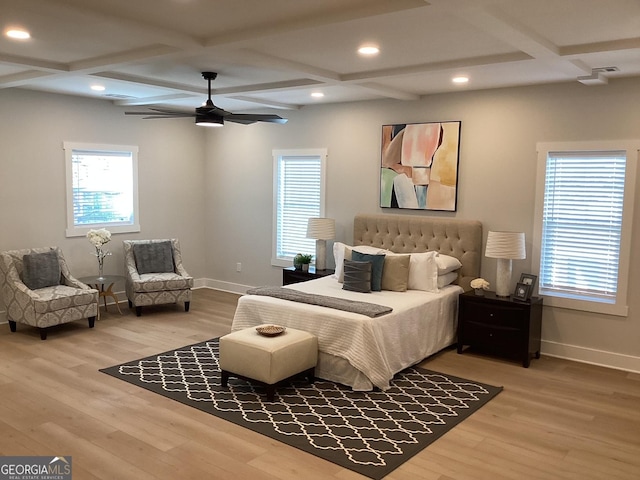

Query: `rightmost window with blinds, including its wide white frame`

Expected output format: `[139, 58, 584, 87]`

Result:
[534, 142, 640, 316]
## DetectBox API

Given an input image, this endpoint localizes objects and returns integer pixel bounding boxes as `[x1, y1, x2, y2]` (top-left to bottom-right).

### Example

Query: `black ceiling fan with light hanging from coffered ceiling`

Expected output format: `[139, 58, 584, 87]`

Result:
[124, 72, 287, 127]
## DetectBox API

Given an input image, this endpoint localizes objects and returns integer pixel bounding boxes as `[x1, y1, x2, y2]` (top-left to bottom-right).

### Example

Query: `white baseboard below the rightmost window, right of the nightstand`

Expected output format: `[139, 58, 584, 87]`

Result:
[541, 340, 640, 373]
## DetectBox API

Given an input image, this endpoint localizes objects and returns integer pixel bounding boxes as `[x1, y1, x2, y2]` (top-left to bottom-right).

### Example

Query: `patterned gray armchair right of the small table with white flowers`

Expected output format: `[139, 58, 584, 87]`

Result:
[123, 238, 193, 316]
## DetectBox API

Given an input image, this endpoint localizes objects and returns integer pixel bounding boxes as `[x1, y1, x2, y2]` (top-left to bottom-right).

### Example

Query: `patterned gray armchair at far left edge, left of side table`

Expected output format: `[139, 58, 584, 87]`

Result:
[0, 247, 98, 340]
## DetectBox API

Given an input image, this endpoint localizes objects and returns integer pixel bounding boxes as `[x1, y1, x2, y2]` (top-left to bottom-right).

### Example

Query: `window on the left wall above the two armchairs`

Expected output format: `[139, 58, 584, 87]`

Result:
[63, 142, 140, 237]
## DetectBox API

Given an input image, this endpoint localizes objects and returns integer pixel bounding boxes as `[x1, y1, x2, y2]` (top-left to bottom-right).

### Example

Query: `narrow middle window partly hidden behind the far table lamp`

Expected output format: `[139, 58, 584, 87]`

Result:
[271, 149, 327, 267]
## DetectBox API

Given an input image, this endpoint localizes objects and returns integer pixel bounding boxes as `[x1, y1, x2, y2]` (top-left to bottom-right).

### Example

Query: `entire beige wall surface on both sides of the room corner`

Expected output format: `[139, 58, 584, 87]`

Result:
[0, 79, 640, 371]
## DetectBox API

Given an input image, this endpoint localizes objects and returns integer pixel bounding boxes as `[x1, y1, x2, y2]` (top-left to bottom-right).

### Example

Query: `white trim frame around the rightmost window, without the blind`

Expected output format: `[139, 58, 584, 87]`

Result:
[531, 140, 640, 317]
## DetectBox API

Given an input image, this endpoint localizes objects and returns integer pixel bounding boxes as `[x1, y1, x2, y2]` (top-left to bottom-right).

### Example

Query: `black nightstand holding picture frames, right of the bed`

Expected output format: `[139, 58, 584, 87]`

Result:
[458, 291, 542, 368]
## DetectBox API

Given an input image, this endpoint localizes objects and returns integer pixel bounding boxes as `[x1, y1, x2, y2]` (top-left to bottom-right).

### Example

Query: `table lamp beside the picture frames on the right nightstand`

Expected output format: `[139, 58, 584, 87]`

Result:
[484, 232, 527, 297]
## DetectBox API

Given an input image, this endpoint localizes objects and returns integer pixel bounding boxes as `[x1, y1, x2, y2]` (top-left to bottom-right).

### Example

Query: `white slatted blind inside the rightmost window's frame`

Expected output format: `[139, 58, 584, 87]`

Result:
[539, 151, 626, 303]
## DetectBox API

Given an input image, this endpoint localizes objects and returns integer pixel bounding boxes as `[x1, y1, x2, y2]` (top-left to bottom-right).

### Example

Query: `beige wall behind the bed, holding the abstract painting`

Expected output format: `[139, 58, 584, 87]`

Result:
[205, 79, 640, 371]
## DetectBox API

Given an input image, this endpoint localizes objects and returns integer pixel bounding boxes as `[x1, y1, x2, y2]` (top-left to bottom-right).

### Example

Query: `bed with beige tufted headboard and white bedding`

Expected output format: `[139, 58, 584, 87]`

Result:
[232, 214, 482, 391]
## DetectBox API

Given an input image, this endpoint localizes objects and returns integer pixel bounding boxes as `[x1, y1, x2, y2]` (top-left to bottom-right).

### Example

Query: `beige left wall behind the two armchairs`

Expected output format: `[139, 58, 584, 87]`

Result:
[0, 89, 206, 280]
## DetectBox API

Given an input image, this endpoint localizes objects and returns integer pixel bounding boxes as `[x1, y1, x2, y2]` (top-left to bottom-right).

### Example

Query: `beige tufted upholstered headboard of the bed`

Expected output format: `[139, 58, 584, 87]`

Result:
[353, 214, 482, 290]
